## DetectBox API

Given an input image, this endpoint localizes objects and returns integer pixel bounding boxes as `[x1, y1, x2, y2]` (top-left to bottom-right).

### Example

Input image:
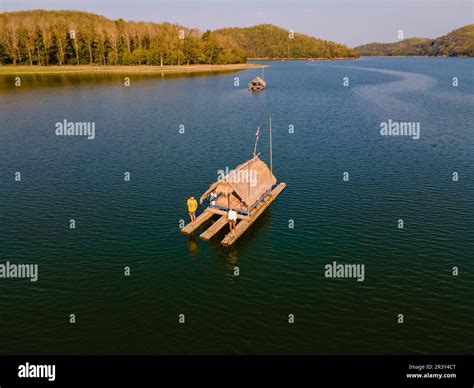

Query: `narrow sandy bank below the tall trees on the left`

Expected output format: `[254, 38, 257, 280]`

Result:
[0, 63, 269, 76]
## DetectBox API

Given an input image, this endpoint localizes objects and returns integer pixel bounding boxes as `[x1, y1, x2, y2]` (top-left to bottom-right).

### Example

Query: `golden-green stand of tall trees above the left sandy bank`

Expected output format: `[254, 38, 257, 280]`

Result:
[0, 10, 247, 66]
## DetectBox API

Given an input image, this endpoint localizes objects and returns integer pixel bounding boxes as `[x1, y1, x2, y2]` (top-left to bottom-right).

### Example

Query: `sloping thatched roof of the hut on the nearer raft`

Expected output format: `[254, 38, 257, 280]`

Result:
[200, 156, 276, 207]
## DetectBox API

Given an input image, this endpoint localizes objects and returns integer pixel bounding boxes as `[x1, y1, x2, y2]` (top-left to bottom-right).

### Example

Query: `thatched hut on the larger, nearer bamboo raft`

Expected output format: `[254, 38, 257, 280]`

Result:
[200, 156, 276, 214]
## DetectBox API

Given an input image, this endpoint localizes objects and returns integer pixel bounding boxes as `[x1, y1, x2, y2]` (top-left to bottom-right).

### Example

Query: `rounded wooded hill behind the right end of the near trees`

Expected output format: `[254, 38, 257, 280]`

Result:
[215, 24, 359, 59]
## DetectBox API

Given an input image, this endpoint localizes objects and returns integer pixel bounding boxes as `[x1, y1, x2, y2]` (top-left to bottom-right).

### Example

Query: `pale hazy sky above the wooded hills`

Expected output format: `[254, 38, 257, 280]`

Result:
[0, 0, 474, 46]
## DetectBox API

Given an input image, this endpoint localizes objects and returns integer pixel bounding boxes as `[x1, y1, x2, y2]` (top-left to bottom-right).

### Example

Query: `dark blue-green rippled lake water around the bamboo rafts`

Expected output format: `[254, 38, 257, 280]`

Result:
[0, 58, 474, 354]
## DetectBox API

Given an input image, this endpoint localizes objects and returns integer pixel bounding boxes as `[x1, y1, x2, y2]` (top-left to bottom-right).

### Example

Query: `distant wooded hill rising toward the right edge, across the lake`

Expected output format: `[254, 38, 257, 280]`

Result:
[355, 24, 474, 57]
